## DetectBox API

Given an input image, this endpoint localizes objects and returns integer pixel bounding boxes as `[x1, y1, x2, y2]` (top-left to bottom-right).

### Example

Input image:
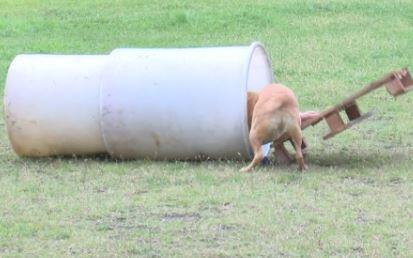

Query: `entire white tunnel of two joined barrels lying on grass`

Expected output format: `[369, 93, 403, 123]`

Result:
[5, 43, 273, 159]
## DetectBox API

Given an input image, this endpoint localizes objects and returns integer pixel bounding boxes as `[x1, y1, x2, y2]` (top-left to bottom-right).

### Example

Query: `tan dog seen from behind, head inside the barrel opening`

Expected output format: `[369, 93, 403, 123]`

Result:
[241, 84, 308, 172]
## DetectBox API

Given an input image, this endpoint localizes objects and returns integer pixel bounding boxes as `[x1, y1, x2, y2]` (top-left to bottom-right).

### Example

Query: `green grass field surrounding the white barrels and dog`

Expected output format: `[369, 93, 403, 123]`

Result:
[0, 0, 413, 257]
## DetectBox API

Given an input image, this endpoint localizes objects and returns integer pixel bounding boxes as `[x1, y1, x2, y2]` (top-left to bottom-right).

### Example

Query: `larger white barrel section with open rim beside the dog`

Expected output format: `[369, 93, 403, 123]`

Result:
[101, 43, 272, 159]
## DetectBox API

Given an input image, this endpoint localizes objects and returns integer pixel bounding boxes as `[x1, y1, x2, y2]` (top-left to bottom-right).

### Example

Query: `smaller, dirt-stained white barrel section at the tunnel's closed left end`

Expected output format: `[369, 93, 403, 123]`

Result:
[4, 55, 107, 156]
